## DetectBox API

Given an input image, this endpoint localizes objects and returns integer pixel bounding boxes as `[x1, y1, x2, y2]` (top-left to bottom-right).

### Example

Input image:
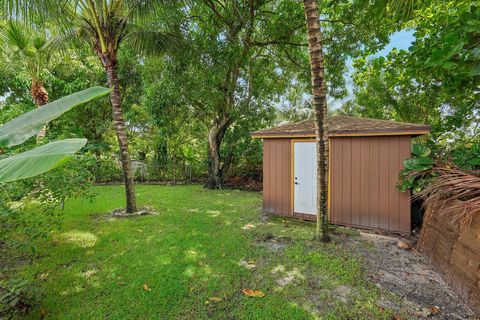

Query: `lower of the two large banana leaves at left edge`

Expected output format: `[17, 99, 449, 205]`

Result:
[0, 139, 87, 183]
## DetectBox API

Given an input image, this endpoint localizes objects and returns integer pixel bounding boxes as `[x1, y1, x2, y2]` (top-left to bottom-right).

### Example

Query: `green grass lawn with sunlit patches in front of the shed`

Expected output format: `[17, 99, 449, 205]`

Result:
[11, 186, 392, 320]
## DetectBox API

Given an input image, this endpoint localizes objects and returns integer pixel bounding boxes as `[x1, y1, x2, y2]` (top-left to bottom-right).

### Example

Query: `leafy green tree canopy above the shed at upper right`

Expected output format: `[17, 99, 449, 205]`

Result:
[342, 0, 480, 146]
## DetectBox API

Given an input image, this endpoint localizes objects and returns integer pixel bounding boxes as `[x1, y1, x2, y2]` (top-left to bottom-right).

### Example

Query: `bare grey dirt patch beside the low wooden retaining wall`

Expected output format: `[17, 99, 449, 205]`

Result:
[346, 232, 477, 320]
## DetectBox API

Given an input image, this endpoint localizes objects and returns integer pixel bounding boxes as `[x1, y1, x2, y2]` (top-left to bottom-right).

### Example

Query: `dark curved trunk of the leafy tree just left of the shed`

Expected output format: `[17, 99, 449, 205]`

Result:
[205, 117, 231, 189]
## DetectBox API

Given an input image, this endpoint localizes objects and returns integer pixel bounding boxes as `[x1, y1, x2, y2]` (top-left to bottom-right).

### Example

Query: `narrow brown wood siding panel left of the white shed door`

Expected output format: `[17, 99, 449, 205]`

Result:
[263, 139, 292, 216]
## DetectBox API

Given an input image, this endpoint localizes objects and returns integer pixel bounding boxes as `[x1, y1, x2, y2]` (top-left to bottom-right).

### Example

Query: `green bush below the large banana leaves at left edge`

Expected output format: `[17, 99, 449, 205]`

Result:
[0, 156, 95, 250]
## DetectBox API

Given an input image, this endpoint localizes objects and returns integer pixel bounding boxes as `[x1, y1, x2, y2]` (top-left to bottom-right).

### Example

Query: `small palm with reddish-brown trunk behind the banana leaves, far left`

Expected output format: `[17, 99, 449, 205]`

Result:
[0, 21, 54, 144]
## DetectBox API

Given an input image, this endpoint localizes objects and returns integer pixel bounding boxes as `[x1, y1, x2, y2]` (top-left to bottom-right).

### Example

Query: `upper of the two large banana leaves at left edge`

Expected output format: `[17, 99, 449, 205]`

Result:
[0, 87, 110, 148]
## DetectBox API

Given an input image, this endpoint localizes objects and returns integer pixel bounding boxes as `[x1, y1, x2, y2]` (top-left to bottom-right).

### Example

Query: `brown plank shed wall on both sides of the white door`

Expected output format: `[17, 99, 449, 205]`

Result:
[263, 136, 411, 233]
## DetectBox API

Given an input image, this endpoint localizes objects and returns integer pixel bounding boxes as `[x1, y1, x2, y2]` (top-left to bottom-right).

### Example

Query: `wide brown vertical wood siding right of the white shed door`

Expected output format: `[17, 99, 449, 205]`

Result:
[330, 136, 410, 232]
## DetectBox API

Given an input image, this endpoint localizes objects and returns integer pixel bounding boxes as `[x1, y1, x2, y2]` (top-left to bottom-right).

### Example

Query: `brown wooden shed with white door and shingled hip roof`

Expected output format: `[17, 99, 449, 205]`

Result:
[251, 116, 430, 233]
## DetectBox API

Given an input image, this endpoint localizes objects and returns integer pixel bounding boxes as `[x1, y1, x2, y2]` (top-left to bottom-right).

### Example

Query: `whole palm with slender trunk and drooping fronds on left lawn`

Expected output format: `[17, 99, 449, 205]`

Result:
[4, 0, 178, 213]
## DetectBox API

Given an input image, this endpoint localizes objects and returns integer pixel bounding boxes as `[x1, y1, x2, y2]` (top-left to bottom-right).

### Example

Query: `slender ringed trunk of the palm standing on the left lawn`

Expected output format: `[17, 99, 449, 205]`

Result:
[102, 60, 137, 213]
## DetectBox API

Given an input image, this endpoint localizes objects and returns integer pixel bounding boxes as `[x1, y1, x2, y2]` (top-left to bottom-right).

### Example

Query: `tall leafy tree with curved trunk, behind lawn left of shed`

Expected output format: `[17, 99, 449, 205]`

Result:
[161, 0, 293, 189]
